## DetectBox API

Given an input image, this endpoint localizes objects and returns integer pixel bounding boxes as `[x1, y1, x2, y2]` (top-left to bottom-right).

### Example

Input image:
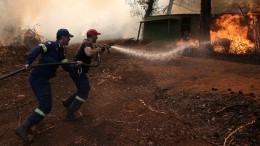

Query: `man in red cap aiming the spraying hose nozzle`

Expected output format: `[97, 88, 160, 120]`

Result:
[62, 29, 104, 121]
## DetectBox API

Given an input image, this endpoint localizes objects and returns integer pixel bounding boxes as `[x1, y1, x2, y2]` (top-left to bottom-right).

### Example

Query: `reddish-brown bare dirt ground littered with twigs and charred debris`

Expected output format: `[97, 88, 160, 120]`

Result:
[0, 40, 260, 146]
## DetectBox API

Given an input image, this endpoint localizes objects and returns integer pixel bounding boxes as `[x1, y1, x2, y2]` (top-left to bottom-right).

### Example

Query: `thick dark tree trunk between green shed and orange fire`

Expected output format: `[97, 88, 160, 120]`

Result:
[200, 0, 211, 51]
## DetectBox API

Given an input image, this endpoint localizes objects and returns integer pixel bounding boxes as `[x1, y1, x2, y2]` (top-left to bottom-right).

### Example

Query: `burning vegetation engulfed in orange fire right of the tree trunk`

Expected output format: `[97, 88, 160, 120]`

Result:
[210, 14, 258, 54]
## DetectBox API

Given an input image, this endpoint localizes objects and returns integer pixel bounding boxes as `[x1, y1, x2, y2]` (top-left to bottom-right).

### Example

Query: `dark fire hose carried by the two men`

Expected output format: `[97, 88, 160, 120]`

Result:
[0, 53, 101, 81]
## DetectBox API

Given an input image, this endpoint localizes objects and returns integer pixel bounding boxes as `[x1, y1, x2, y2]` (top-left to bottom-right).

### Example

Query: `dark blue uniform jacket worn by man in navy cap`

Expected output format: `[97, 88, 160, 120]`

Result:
[25, 41, 69, 79]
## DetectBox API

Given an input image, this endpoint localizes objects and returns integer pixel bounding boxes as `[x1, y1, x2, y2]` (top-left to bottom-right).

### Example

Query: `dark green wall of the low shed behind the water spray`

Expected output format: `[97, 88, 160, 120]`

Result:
[143, 14, 200, 40]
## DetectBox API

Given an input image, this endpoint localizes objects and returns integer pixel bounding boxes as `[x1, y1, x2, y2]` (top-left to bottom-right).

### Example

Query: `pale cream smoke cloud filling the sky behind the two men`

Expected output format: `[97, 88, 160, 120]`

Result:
[0, 0, 140, 42]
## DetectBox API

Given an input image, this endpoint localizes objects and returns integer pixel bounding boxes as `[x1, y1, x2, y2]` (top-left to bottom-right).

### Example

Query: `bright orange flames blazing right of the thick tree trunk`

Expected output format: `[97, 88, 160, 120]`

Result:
[210, 14, 255, 54]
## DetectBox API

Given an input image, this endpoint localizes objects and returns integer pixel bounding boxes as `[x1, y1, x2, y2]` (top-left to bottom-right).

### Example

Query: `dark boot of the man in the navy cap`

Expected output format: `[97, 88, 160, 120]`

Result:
[15, 120, 32, 142]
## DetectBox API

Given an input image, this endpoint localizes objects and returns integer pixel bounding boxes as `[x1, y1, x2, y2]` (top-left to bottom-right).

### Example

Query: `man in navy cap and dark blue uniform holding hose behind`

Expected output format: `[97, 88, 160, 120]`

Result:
[15, 29, 73, 142]
